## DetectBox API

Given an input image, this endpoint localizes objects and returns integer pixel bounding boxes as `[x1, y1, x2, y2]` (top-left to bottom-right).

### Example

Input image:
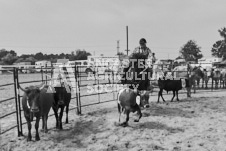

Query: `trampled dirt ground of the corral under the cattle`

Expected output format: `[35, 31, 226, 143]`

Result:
[0, 90, 226, 151]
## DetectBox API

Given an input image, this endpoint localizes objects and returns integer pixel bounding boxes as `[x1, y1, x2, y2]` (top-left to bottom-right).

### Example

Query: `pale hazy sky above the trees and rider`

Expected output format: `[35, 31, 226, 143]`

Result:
[0, 0, 226, 59]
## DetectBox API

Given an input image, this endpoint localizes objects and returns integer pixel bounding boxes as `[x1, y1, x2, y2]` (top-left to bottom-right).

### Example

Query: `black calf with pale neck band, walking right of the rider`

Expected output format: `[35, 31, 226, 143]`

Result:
[157, 77, 190, 103]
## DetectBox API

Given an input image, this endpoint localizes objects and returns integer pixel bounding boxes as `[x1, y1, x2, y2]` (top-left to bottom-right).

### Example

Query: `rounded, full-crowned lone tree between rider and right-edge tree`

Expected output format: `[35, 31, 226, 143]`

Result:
[180, 40, 203, 62]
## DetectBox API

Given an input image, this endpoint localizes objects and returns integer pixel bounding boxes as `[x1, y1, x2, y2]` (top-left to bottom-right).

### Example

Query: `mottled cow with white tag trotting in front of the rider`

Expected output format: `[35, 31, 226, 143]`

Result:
[118, 88, 150, 127]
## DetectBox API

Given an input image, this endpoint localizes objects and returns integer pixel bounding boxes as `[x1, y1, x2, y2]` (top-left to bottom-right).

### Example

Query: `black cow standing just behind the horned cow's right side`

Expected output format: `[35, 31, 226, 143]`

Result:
[53, 83, 71, 129]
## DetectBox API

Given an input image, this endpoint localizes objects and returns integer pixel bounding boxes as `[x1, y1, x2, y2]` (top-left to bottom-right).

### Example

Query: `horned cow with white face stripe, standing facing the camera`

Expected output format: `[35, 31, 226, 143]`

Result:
[20, 85, 54, 141]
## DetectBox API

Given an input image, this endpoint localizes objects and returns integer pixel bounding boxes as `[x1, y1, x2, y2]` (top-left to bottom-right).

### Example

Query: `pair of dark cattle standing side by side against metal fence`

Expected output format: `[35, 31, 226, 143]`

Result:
[20, 81, 71, 141]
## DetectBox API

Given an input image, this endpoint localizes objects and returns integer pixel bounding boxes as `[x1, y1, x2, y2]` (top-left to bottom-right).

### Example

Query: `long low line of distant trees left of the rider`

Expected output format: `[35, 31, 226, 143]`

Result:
[0, 49, 91, 65]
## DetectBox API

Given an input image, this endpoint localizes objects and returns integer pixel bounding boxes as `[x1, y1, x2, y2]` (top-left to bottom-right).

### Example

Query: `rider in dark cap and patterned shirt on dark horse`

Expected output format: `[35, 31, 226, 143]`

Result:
[121, 38, 156, 87]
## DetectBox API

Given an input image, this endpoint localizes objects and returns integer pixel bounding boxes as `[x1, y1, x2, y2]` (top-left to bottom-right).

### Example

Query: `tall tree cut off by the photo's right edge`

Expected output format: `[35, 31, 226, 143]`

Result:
[211, 28, 226, 60]
